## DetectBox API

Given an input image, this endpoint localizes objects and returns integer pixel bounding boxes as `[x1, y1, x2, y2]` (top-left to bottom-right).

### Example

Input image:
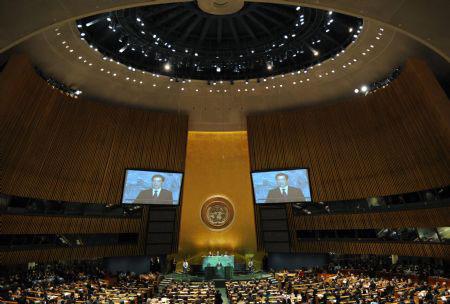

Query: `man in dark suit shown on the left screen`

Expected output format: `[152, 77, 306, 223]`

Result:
[134, 174, 174, 205]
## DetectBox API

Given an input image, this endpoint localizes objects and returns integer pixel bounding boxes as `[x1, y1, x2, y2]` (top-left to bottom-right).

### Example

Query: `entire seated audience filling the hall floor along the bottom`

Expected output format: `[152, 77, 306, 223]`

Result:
[0, 259, 450, 304]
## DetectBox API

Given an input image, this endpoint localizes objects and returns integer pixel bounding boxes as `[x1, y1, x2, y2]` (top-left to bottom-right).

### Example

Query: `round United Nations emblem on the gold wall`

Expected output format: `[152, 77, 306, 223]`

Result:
[201, 196, 234, 230]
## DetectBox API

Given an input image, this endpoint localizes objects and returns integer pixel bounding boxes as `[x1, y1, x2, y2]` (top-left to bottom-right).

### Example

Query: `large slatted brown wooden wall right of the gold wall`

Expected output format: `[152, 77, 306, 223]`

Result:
[247, 60, 450, 201]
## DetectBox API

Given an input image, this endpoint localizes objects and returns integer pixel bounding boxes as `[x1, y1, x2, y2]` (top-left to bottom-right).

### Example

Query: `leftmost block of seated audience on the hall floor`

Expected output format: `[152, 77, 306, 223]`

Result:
[0, 264, 158, 304]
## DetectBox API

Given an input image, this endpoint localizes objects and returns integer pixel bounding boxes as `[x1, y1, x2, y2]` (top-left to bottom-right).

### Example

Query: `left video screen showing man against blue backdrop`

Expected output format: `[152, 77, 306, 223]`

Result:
[122, 170, 183, 205]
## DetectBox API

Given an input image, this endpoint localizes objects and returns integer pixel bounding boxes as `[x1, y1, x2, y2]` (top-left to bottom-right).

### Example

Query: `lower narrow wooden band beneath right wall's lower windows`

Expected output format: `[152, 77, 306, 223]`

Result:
[294, 241, 450, 259]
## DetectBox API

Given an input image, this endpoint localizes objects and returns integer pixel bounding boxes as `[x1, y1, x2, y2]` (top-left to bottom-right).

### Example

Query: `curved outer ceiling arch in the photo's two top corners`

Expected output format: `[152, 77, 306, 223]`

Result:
[0, 0, 450, 62]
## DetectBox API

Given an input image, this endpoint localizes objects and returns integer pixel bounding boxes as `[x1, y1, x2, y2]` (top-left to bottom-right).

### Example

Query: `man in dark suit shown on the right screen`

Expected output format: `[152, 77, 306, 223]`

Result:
[266, 173, 306, 203]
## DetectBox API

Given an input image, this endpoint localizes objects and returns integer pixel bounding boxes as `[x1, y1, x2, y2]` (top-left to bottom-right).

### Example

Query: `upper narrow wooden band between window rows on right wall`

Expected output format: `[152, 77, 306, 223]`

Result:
[288, 206, 450, 230]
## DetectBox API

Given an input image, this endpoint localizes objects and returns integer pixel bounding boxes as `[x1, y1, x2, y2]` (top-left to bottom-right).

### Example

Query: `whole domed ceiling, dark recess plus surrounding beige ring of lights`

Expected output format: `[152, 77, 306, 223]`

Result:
[5, 0, 448, 131]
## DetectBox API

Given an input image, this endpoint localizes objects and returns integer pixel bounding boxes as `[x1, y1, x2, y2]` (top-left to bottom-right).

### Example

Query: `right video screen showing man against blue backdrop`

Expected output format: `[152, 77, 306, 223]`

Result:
[252, 169, 311, 204]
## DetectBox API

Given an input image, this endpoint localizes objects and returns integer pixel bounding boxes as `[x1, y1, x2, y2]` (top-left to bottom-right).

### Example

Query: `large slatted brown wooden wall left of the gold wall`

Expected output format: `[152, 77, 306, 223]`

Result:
[0, 56, 188, 204]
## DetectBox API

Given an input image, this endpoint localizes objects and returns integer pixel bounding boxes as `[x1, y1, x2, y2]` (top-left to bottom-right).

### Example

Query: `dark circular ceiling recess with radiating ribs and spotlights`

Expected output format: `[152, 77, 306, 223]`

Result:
[77, 0, 363, 81]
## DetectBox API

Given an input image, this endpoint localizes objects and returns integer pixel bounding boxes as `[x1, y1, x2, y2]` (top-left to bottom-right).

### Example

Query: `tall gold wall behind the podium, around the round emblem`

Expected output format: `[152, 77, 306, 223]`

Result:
[179, 132, 256, 255]
